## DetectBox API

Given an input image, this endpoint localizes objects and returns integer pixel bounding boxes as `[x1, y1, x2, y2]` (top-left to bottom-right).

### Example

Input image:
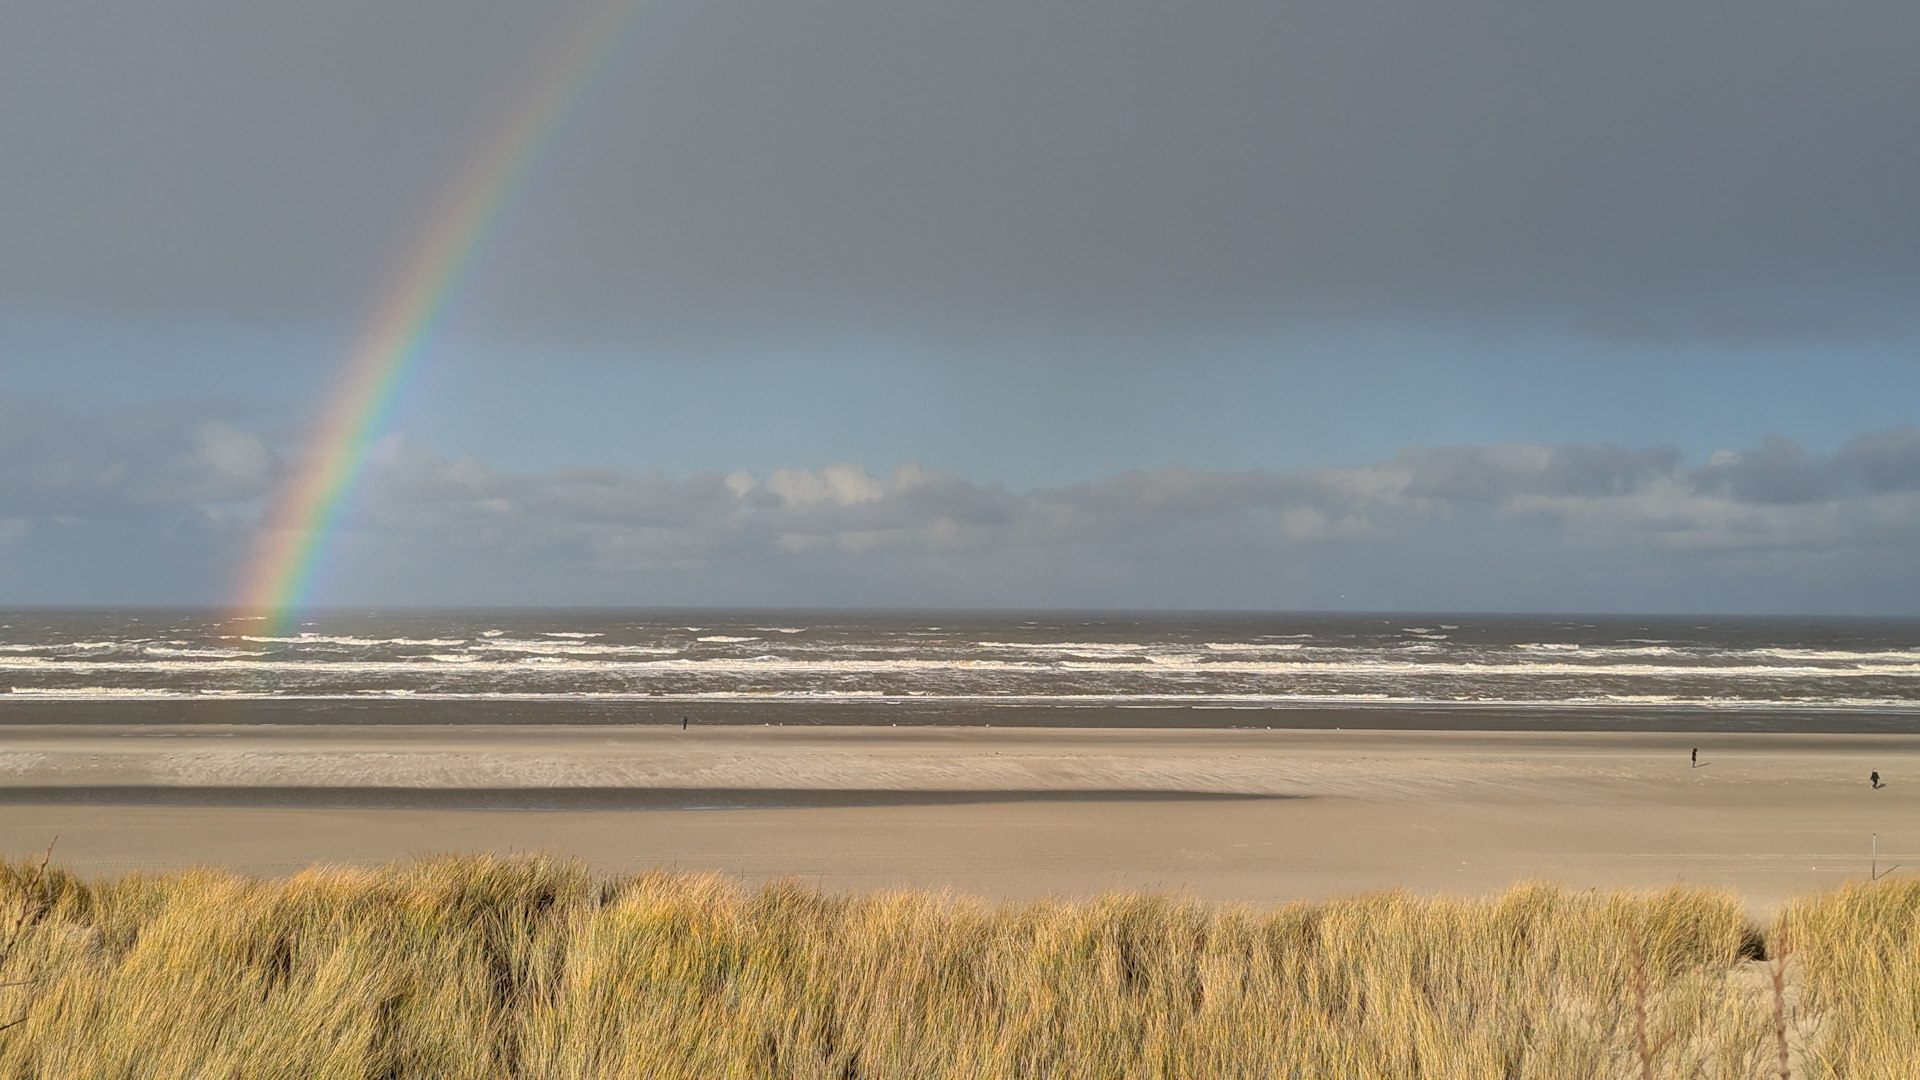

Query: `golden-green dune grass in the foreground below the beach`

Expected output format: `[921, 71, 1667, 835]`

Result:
[0, 857, 1920, 1080]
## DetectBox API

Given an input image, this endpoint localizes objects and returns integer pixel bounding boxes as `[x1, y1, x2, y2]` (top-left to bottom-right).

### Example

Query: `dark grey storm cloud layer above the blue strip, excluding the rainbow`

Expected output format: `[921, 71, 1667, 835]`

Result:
[0, 0, 1920, 338]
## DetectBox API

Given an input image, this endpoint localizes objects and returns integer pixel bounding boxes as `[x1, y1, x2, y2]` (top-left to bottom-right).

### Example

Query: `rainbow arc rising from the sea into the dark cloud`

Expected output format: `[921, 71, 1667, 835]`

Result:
[236, 0, 641, 636]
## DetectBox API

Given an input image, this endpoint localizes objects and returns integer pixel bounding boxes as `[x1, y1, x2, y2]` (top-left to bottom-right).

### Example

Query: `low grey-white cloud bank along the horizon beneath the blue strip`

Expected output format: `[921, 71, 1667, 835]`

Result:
[0, 405, 1920, 613]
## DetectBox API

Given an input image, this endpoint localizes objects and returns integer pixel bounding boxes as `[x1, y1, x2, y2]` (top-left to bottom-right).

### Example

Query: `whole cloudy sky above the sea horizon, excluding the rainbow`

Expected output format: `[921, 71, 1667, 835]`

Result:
[0, 0, 1920, 613]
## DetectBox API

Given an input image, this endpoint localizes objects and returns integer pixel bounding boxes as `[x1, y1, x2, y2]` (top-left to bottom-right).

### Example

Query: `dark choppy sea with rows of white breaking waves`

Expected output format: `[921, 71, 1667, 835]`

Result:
[0, 609, 1920, 732]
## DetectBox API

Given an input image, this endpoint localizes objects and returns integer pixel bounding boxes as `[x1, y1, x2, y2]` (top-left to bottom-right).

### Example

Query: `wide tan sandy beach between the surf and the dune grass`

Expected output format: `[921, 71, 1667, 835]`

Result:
[0, 723, 1920, 911]
